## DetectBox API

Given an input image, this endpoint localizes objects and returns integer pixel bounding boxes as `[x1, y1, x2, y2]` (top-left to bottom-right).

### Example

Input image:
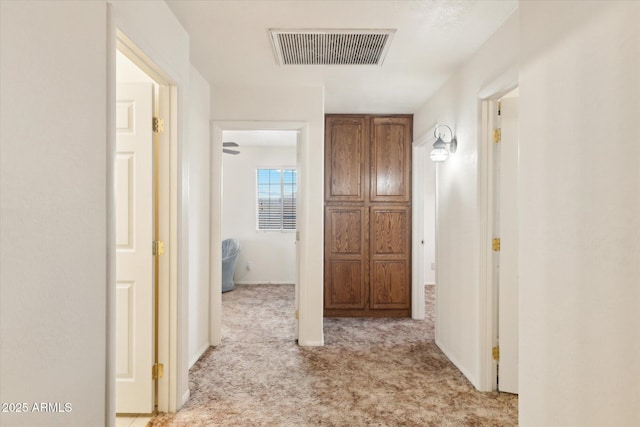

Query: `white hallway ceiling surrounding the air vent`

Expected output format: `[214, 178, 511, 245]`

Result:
[167, 0, 518, 113]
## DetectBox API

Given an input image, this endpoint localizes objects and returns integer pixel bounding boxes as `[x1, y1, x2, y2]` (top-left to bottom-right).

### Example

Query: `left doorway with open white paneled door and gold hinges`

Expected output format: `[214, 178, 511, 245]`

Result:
[110, 30, 177, 415]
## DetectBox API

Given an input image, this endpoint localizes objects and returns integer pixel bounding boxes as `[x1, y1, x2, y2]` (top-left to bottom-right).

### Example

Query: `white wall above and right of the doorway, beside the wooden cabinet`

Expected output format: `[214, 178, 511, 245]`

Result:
[211, 87, 324, 345]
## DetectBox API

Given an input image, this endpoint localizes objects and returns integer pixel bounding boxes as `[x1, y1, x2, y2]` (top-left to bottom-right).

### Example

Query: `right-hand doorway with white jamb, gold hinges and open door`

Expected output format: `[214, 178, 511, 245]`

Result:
[481, 88, 519, 394]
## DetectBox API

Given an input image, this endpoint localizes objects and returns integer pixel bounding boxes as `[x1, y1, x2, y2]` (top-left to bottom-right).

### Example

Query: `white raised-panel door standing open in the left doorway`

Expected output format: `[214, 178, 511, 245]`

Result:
[115, 83, 154, 413]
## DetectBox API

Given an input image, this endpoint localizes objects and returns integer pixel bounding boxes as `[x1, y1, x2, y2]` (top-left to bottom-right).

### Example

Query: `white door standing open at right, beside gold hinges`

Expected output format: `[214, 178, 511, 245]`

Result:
[498, 98, 518, 393]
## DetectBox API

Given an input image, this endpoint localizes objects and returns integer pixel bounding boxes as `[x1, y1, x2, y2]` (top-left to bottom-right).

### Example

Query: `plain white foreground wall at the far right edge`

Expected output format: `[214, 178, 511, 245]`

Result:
[519, 1, 640, 427]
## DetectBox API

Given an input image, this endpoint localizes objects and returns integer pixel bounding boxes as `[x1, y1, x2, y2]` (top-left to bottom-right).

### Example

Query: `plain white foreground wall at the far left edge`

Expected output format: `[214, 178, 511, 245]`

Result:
[0, 1, 108, 427]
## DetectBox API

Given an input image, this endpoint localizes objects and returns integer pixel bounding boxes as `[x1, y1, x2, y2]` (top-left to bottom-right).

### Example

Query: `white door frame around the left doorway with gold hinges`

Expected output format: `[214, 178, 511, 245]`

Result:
[107, 29, 179, 417]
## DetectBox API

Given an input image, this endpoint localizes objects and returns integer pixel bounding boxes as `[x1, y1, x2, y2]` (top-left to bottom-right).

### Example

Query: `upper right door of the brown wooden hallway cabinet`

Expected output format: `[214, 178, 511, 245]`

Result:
[370, 117, 411, 202]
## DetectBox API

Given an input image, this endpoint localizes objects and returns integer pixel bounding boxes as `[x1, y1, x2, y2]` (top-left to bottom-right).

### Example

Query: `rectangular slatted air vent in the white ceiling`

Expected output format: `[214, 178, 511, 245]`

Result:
[269, 29, 396, 65]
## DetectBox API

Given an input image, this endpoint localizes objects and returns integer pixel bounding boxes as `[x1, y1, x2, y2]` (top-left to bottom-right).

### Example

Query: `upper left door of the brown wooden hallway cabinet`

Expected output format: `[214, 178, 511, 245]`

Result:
[325, 117, 368, 202]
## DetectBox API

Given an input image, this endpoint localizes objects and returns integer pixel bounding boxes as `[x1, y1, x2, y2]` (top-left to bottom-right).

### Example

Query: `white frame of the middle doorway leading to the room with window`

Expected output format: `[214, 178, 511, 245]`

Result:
[209, 120, 308, 346]
